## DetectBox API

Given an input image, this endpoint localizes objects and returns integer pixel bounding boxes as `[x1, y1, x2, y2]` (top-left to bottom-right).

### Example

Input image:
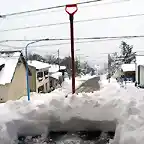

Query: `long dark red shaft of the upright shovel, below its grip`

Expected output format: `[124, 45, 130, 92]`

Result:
[70, 14, 75, 94]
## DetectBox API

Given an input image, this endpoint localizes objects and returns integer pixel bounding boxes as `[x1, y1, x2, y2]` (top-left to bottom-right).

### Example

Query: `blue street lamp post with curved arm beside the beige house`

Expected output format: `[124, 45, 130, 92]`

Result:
[25, 38, 50, 101]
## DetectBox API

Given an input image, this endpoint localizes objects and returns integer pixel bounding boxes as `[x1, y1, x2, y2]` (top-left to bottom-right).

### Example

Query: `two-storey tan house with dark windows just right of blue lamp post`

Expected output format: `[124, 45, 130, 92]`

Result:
[28, 60, 50, 93]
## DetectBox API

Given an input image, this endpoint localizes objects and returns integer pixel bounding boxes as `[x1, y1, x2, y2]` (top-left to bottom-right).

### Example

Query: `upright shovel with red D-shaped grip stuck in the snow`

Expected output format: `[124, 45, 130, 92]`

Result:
[65, 4, 78, 94]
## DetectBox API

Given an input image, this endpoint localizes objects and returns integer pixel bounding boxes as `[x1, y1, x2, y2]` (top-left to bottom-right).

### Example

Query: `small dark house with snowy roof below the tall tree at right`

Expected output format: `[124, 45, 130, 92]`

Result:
[121, 63, 136, 82]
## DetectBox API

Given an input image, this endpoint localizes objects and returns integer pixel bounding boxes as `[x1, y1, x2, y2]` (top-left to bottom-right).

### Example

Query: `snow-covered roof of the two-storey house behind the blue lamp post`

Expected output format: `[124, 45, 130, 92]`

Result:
[28, 60, 50, 69]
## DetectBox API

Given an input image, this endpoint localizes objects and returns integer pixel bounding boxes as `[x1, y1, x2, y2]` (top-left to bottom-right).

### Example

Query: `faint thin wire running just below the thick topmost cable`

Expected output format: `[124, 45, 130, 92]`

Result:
[3, 0, 130, 18]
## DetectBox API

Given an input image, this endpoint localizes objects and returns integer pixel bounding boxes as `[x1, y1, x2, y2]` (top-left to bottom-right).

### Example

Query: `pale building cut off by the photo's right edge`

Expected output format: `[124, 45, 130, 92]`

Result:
[136, 54, 144, 87]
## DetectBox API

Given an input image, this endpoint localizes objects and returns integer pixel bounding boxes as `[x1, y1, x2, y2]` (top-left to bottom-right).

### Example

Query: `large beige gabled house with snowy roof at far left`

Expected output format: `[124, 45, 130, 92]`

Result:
[0, 51, 31, 102]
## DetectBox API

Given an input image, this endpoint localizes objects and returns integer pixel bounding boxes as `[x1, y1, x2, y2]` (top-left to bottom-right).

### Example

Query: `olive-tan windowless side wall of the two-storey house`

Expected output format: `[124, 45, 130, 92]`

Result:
[29, 66, 36, 92]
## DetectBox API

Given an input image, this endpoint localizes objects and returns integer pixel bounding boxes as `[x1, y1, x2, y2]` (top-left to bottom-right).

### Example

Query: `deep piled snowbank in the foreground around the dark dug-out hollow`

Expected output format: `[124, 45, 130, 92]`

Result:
[0, 77, 144, 144]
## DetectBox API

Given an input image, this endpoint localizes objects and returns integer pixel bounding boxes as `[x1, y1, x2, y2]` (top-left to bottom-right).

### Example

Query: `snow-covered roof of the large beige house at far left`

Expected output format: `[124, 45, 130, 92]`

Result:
[0, 52, 21, 85]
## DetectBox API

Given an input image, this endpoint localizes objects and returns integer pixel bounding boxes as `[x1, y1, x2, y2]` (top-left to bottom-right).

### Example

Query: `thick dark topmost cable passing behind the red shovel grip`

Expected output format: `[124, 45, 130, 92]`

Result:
[0, 0, 102, 18]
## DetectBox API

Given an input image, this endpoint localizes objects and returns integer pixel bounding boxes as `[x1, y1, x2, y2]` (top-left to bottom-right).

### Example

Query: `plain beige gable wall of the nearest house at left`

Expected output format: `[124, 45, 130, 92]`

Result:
[8, 63, 27, 100]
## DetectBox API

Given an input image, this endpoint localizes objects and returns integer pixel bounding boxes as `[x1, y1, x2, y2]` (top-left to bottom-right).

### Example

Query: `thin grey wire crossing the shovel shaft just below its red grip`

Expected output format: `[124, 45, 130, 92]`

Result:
[0, 13, 144, 32]
